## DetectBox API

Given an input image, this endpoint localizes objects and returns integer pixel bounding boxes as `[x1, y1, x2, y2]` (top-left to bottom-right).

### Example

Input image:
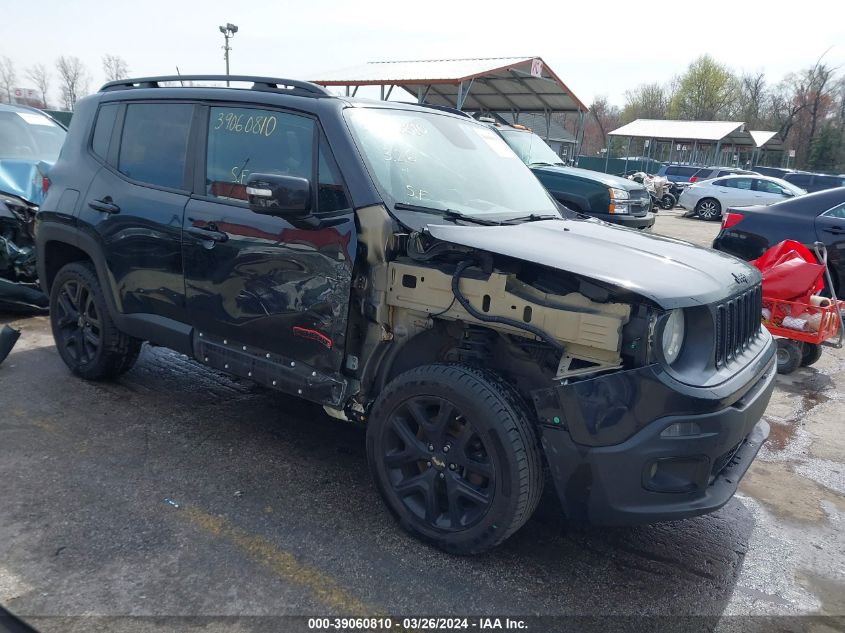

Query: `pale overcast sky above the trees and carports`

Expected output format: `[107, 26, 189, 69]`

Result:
[0, 0, 845, 105]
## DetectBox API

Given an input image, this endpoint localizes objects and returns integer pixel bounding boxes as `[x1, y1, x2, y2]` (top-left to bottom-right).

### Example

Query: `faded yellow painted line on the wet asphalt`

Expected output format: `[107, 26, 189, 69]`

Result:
[180, 506, 383, 617]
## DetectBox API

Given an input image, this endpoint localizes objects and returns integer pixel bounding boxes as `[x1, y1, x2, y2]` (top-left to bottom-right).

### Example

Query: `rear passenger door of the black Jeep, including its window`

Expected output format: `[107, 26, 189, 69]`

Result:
[79, 102, 194, 322]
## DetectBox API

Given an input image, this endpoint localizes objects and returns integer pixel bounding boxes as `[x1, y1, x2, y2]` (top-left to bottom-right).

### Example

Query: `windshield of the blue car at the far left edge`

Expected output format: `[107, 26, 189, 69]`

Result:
[0, 111, 67, 163]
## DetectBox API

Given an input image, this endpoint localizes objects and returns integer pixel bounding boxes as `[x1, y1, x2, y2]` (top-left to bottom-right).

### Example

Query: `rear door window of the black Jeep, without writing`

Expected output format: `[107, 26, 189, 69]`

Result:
[117, 103, 194, 189]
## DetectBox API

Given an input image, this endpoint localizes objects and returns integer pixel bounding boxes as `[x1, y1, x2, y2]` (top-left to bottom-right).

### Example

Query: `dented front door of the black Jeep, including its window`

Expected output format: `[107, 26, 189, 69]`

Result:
[183, 105, 357, 372]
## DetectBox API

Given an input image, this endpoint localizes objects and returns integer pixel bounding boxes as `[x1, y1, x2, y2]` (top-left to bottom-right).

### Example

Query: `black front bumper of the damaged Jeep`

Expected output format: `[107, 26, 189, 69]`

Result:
[535, 355, 776, 525]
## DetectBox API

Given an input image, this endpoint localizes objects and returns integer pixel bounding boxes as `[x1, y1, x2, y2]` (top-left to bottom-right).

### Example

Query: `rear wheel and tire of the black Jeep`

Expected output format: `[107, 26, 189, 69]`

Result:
[50, 262, 142, 380]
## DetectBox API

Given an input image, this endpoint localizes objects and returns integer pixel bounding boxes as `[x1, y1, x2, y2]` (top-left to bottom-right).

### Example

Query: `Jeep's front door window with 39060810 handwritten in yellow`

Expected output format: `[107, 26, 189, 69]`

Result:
[205, 108, 314, 201]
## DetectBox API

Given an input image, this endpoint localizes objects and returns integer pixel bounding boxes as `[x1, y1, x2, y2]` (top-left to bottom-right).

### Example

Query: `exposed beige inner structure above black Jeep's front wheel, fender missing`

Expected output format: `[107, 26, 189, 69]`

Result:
[346, 207, 649, 400]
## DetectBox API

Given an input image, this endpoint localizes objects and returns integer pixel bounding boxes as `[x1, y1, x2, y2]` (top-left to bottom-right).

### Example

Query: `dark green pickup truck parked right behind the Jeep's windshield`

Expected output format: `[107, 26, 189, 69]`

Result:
[491, 125, 654, 229]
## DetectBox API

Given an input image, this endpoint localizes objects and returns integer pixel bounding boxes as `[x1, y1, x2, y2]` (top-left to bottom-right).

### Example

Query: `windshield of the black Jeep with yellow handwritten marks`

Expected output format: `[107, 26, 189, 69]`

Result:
[345, 108, 559, 216]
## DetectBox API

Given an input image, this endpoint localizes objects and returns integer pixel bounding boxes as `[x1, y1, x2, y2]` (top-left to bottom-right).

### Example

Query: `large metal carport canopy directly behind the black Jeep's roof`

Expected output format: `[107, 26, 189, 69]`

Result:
[312, 57, 587, 114]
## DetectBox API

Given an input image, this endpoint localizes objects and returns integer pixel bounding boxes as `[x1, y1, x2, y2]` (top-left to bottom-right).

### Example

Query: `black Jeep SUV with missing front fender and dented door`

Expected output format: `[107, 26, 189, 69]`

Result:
[37, 76, 775, 553]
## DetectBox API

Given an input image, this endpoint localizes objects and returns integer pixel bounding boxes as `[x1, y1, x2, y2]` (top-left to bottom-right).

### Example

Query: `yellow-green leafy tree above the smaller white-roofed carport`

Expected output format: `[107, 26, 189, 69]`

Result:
[669, 55, 739, 121]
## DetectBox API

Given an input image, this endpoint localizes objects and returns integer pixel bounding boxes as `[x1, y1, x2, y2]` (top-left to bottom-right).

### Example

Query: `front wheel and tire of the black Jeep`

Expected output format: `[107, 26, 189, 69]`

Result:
[367, 365, 543, 554]
